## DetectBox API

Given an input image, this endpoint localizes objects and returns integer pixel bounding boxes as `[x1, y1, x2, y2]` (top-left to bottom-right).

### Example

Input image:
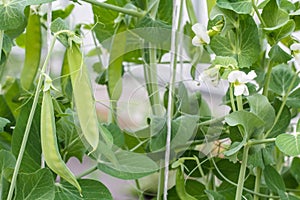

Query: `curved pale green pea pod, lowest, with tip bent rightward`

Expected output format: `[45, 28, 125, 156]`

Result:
[41, 90, 81, 194]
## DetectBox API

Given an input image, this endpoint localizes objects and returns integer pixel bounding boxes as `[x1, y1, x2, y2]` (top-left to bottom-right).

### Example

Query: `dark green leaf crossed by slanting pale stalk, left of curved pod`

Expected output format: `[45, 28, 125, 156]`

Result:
[12, 101, 42, 173]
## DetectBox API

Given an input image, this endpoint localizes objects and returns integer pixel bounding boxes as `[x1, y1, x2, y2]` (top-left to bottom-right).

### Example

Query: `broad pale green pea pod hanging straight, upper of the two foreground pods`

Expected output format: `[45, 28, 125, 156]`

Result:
[67, 43, 99, 151]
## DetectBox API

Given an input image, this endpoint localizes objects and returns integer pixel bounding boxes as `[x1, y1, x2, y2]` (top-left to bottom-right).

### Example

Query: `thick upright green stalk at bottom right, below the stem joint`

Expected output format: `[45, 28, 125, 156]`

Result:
[235, 144, 250, 200]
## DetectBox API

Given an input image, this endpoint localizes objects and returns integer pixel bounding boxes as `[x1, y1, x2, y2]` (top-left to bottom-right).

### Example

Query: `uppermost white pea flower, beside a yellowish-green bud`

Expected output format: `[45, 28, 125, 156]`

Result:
[192, 23, 210, 46]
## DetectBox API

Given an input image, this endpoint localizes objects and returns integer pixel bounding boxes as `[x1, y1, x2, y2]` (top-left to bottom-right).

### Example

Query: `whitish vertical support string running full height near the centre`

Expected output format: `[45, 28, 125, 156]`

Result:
[163, 0, 182, 200]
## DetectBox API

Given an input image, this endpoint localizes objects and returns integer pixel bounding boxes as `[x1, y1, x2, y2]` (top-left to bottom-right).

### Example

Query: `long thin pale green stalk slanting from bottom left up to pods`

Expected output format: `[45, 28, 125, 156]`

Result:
[7, 35, 57, 200]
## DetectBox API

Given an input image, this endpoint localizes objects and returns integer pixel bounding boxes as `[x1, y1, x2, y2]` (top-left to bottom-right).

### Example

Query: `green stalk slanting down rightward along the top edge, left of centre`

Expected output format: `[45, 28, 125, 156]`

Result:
[82, 0, 146, 18]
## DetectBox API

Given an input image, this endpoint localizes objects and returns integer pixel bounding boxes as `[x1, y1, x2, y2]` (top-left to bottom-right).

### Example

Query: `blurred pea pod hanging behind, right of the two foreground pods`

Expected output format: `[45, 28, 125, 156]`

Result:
[108, 22, 127, 101]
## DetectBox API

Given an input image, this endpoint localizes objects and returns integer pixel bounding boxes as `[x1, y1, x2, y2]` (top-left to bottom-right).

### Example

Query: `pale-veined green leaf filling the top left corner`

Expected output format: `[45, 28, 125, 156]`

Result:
[0, 0, 26, 31]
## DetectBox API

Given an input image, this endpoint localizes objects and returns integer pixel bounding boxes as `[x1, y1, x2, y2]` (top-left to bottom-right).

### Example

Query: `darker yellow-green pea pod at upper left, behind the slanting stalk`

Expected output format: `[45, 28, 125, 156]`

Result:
[20, 11, 42, 90]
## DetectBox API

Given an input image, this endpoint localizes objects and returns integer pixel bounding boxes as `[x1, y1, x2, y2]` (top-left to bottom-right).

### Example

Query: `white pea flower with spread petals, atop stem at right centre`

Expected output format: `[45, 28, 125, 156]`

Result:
[228, 70, 256, 96]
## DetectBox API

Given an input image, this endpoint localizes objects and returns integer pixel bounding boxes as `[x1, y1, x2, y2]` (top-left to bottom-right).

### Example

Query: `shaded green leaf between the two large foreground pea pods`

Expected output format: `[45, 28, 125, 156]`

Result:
[56, 108, 86, 161]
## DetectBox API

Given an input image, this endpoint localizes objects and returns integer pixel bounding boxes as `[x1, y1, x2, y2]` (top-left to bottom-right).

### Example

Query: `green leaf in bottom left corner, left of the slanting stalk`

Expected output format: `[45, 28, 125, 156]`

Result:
[0, 150, 16, 200]
